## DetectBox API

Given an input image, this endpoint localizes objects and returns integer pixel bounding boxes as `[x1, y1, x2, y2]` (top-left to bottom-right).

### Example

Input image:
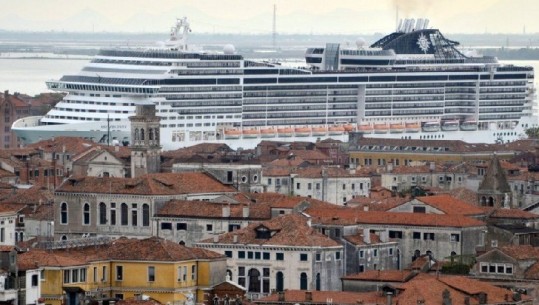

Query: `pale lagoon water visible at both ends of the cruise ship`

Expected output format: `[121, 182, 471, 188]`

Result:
[0, 54, 539, 96]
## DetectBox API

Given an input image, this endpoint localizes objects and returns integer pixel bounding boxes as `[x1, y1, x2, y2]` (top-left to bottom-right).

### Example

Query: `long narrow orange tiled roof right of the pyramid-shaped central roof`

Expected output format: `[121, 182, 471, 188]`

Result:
[305, 209, 485, 228]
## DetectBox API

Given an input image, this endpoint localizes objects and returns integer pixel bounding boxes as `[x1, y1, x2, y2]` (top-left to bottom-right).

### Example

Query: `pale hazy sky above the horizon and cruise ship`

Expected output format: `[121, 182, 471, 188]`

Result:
[0, 0, 539, 34]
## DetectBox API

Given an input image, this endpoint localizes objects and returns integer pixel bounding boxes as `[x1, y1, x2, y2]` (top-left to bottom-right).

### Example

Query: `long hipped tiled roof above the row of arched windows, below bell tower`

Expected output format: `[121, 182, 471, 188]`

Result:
[56, 172, 235, 195]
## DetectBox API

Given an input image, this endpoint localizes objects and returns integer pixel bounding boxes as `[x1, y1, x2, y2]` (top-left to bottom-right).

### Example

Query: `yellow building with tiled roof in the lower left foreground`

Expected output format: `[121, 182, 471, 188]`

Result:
[19, 237, 226, 305]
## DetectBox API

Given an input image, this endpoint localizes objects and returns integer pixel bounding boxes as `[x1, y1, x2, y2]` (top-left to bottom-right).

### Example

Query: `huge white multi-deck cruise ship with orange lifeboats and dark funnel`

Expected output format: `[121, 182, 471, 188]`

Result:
[12, 18, 538, 150]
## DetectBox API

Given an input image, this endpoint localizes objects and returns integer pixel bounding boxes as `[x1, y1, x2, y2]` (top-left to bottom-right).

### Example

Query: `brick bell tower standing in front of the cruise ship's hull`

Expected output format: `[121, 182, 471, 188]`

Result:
[129, 104, 161, 178]
